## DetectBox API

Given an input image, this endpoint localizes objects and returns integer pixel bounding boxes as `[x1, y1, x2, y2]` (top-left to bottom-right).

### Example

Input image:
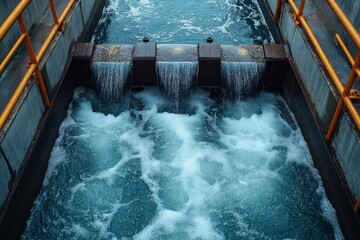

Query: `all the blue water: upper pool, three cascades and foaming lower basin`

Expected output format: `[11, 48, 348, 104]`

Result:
[22, 0, 343, 240]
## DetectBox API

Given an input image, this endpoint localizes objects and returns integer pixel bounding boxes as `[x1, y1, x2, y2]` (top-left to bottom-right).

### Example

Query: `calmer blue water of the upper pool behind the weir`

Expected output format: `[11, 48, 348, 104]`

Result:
[93, 0, 273, 44]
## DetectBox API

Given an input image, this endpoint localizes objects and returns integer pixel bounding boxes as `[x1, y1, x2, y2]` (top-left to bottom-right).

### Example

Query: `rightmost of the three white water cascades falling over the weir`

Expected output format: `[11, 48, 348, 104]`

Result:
[221, 61, 265, 100]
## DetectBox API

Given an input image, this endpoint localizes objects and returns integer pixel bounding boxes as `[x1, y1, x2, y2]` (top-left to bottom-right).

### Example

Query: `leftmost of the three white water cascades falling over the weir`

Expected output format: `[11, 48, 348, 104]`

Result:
[91, 62, 131, 102]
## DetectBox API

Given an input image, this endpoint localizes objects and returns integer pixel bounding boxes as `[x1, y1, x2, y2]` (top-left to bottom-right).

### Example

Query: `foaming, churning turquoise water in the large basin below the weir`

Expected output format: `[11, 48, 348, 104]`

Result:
[23, 88, 342, 240]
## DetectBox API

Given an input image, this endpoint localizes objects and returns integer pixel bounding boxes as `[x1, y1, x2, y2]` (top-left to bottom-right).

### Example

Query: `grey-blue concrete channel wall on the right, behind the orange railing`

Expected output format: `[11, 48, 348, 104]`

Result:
[268, 0, 360, 197]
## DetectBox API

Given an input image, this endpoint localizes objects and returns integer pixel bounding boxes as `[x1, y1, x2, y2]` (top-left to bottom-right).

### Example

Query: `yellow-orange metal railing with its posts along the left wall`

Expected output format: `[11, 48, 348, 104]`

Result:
[0, 0, 78, 129]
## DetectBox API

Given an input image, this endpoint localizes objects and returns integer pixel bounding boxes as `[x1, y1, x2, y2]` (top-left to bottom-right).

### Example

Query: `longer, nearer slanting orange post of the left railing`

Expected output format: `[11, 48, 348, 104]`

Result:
[18, 15, 50, 107]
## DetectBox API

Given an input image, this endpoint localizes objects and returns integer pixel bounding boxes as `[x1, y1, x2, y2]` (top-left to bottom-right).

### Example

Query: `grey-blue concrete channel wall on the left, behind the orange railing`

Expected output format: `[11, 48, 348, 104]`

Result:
[0, 0, 105, 224]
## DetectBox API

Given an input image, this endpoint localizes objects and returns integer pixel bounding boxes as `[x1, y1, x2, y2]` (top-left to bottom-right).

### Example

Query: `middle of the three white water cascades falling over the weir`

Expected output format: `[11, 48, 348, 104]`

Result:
[157, 62, 198, 111]
